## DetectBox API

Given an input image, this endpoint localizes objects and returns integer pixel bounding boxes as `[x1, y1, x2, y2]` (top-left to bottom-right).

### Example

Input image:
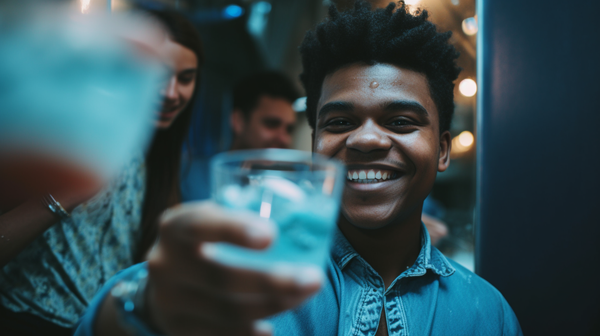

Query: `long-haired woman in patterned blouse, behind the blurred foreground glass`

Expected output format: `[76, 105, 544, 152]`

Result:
[0, 10, 204, 335]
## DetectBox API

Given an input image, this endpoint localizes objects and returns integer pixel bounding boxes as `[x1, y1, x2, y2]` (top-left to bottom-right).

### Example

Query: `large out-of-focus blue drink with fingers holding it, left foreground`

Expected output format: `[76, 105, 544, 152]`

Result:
[0, 2, 167, 201]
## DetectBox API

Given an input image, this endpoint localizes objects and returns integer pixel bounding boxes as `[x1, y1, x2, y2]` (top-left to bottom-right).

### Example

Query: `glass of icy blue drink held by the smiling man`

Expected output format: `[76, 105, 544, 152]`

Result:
[211, 149, 346, 271]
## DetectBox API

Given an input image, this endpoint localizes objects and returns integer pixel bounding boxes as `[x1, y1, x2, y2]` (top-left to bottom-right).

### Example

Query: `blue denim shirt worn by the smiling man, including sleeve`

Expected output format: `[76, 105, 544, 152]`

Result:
[75, 225, 523, 336]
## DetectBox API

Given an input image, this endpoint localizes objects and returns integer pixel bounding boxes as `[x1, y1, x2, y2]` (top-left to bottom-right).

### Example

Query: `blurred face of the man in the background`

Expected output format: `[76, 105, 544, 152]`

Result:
[234, 96, 296, 149]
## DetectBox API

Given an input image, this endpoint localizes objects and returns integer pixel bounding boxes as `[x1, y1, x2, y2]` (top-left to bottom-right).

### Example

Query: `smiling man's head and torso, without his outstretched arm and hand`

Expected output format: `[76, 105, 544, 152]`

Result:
[273, 2, 521, 335]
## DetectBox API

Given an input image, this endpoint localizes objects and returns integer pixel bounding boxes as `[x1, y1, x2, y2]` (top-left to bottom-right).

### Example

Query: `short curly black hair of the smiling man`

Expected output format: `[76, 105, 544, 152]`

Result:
[300, 1, 461, 133]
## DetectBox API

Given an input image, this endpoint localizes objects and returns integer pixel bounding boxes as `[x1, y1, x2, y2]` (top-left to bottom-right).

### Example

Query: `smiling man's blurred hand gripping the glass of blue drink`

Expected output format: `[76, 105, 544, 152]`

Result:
[147, 202, 323, 336]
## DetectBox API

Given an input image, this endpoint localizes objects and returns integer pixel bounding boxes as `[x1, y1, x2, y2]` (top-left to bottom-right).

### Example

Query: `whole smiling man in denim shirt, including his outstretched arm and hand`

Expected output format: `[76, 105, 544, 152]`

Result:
[76, 2, 522, 336]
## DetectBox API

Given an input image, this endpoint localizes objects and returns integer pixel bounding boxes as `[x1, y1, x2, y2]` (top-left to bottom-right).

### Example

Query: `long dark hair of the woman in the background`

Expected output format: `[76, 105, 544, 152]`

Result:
[135, 9, 204, 262]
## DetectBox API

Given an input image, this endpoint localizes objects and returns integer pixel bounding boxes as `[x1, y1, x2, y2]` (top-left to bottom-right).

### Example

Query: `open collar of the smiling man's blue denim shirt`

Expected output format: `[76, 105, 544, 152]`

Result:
[331, 223, 455, 282]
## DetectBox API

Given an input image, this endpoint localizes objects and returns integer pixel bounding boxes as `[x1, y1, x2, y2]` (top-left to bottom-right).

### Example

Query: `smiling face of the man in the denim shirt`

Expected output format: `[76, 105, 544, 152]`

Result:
[313, 64, 450, 229]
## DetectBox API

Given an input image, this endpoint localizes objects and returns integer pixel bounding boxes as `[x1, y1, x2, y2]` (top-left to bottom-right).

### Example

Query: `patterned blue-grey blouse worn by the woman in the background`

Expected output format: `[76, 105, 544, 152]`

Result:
[0, 153, 146, 328]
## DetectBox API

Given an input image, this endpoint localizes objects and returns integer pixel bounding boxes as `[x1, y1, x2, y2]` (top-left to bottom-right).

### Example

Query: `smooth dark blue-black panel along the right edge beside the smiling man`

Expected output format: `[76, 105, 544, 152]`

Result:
[476, 0, 600, 335]
